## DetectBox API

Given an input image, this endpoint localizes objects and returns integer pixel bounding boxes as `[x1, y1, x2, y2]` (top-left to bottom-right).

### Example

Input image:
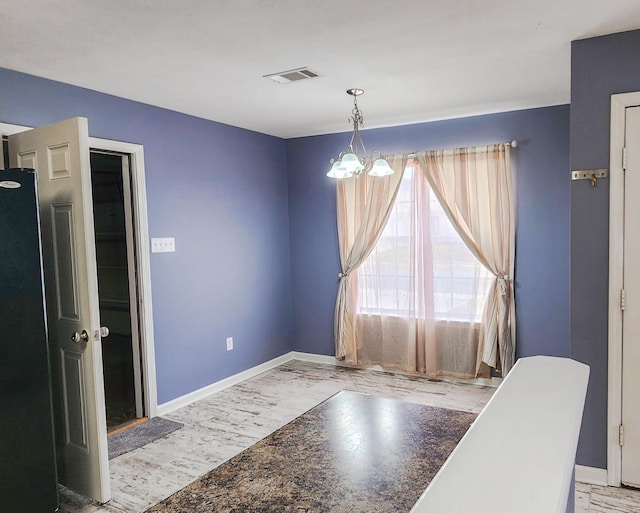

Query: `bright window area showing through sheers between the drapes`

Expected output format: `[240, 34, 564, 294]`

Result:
[358, 165, 493, 322]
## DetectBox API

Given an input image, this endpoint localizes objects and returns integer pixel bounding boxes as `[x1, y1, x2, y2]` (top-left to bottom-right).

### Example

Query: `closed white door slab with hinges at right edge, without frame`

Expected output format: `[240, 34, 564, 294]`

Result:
[621, 107, 640, 487]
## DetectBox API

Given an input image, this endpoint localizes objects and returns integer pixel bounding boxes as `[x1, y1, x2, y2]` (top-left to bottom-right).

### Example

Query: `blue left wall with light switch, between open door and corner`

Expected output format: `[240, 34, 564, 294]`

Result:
[0, 68, 292, 403]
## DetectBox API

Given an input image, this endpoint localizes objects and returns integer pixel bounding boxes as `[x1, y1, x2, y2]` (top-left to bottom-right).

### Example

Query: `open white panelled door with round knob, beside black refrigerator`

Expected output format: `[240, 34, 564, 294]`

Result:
[9, 118, 110, 502]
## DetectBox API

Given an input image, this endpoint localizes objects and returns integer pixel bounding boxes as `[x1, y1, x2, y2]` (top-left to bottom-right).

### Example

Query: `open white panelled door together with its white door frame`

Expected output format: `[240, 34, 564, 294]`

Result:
[0, 118, 158, 502]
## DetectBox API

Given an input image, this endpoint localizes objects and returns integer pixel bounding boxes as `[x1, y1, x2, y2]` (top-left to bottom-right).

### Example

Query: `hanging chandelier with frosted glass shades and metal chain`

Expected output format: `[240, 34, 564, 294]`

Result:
[327, 89, 393, 178]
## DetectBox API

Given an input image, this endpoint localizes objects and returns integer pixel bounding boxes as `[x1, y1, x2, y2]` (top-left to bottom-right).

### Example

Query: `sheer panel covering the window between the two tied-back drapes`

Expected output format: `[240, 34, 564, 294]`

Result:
[356, 162, 490, 377]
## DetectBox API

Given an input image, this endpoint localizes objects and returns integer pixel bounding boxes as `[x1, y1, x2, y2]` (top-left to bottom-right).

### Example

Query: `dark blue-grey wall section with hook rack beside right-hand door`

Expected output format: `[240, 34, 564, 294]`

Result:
[571, 30, 640, 468]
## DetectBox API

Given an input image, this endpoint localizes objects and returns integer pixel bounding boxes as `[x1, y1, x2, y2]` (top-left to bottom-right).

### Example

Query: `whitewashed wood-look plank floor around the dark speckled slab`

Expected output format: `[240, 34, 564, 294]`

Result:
[61, 360, 640, 513]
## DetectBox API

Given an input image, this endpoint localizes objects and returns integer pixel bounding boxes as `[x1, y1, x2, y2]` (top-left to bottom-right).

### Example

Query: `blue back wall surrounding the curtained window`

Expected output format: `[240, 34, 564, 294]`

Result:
[288, 105, 570, 364]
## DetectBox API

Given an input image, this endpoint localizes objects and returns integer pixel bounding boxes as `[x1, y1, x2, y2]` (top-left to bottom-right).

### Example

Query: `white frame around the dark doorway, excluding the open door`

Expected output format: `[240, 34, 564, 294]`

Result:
[0, 123, 158, 418]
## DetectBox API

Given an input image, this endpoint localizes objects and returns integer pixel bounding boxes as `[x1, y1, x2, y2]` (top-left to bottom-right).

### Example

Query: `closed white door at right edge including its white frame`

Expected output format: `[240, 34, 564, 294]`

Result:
[607, 93, 640, 487]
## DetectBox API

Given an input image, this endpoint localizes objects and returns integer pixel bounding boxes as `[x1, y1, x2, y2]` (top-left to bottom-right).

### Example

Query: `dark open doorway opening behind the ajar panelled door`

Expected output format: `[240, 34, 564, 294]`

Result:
[90, 149, 144, 433]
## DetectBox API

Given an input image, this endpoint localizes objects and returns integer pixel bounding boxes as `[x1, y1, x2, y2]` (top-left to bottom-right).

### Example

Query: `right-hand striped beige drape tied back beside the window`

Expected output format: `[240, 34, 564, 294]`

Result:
[417, 144, 516, 375]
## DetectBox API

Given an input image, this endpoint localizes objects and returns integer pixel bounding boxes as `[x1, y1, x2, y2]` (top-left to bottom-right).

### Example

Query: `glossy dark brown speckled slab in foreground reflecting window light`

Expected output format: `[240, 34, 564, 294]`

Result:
[147, 391, 476, 513]
